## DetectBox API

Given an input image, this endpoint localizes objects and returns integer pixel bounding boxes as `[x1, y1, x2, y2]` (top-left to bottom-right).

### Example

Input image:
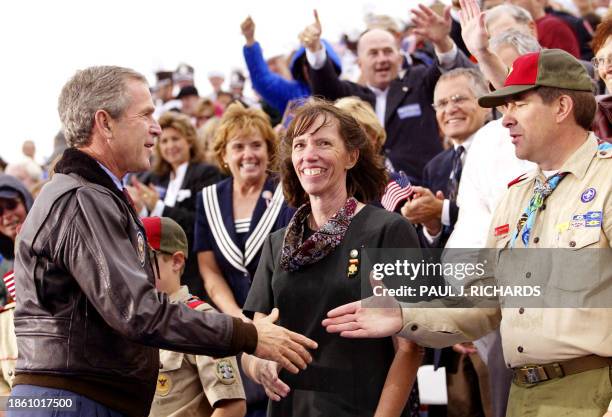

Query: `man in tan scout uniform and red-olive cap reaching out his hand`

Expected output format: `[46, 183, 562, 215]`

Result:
[323, 49, 612, 417]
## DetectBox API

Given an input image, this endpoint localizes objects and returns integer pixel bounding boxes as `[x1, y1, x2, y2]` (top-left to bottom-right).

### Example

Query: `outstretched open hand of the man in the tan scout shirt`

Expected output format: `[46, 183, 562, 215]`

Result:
[322, 297, 403, 338]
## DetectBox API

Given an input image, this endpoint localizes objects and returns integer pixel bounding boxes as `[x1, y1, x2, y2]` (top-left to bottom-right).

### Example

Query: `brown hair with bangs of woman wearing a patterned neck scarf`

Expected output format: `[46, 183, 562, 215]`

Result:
[280, 99, 387, 207]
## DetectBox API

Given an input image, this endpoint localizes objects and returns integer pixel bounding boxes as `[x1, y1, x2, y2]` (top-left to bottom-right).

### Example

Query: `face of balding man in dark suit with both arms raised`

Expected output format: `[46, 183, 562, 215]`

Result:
[357, 29, 402, 90]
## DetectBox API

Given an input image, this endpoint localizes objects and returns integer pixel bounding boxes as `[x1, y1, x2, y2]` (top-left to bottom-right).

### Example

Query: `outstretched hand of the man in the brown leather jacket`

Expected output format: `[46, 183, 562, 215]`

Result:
[253, 308, 317, 374]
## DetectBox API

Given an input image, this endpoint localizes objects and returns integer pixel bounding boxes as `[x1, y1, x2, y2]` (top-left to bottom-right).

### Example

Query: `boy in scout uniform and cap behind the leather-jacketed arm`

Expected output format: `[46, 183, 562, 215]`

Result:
[142, 217, 246, 417]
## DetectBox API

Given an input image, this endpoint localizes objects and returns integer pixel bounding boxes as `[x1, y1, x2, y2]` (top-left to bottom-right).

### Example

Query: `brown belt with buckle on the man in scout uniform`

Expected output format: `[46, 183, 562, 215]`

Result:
[512, 355, 612, 387]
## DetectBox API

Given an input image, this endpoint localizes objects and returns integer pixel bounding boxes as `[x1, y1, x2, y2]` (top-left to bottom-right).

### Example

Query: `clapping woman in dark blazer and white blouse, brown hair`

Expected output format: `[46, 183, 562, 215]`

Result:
[131, 112, 222, 297]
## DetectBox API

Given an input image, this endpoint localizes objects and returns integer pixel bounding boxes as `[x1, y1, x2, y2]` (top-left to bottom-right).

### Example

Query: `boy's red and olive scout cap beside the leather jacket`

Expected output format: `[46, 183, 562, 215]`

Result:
[142, 217, 189, 258]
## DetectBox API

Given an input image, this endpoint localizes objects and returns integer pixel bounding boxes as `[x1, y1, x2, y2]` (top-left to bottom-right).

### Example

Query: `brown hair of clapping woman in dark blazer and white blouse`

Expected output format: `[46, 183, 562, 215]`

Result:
[152, 111, 202, 176]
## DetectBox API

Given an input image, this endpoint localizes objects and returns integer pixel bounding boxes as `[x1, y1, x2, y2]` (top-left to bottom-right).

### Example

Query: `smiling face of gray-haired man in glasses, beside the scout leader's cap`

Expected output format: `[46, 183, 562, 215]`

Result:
[434, 76, 488, 142]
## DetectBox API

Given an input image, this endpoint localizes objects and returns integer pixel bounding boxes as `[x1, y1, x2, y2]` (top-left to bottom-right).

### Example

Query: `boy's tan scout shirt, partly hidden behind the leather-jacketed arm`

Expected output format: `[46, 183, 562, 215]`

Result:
[149, 286, 245, 417]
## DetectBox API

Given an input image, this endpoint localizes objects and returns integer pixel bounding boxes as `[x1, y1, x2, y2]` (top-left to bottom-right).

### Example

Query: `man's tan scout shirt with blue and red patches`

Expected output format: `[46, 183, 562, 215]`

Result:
[400, 134, 612, 374]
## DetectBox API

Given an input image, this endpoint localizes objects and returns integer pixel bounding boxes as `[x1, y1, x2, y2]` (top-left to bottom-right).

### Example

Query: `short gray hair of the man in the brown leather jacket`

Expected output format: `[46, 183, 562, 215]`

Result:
[58, 66, 147, 147]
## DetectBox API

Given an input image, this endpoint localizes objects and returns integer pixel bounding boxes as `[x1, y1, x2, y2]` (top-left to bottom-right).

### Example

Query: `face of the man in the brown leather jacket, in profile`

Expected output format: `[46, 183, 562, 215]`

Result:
[107, 80, 161, 174]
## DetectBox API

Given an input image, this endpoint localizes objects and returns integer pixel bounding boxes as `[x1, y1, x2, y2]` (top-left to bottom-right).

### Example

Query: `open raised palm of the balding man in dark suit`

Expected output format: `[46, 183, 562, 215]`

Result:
[411, 4, 453, 53]
